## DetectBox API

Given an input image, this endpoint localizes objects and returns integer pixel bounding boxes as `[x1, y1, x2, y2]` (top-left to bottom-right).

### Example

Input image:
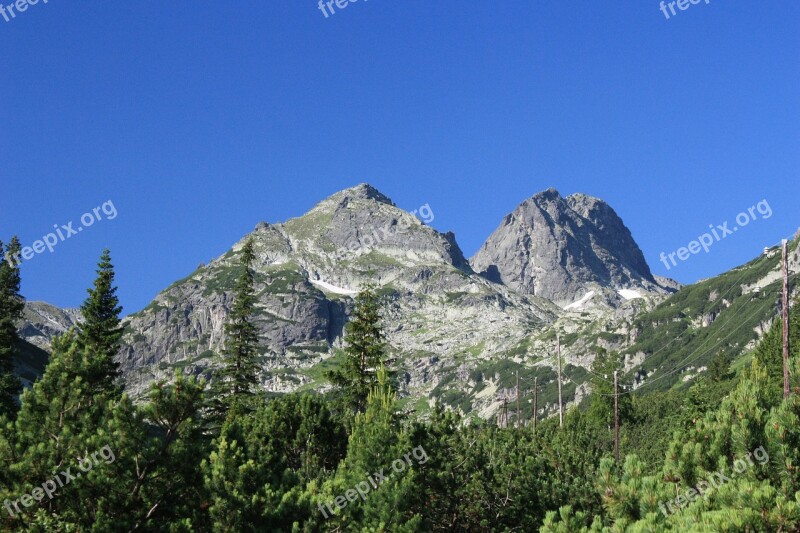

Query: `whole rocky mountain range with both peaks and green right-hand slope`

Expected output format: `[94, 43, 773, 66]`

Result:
[18, 184, 800, 418]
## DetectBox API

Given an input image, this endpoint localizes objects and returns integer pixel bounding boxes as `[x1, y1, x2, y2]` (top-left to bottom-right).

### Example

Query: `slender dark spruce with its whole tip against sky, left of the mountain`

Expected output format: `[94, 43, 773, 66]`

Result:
[80, 249, 122, 391]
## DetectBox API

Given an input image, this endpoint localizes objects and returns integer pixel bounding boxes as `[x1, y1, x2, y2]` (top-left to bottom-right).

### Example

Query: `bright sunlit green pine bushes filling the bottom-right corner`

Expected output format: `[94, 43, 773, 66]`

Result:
[541, 338, 800, 533]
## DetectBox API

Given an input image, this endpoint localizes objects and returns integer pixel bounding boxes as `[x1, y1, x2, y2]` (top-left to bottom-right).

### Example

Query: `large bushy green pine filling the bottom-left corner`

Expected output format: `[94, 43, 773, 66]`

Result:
[0, 331, 207, 531]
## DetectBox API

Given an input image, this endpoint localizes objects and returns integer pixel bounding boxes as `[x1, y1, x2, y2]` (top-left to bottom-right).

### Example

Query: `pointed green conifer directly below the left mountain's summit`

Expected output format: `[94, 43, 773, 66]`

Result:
[326, 285, 386, 413]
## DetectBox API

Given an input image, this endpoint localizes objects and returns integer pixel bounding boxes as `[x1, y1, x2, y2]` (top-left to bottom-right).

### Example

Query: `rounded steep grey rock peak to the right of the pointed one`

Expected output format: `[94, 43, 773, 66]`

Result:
[470, 189, 664, 306]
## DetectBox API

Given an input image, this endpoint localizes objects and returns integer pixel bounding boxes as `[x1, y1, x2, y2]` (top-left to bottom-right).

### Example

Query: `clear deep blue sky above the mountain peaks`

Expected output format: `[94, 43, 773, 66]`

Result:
[0, 0, 800, 314]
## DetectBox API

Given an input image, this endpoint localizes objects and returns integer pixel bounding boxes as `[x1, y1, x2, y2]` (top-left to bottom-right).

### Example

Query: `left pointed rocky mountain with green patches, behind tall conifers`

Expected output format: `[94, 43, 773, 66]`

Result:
[120, 185, 557, 400]
